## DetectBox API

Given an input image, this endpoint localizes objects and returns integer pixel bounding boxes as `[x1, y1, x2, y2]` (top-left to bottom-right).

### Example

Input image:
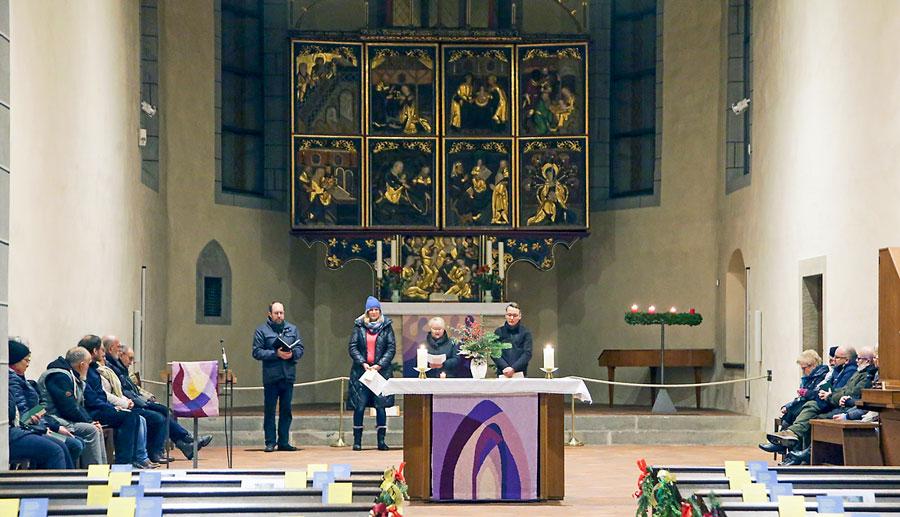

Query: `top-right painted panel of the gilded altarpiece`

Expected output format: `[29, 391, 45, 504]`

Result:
[516, 43, 588, 136]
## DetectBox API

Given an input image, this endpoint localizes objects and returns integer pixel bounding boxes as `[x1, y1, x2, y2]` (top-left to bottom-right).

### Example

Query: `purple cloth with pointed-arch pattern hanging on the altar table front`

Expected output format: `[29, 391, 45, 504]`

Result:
[431, 394, 538, 501]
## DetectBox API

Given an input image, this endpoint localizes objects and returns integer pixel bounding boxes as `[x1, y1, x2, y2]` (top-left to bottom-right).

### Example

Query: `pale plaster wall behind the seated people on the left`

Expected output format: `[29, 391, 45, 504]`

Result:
[9, 0, 167, 376]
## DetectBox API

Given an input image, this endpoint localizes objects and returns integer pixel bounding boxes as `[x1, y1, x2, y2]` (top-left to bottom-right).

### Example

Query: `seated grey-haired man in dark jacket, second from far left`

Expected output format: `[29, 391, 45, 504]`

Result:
[38, 346, 107, 466]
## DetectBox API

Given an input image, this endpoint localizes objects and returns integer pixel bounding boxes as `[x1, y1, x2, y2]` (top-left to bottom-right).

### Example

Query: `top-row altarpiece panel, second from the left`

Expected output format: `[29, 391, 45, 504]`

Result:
[366, 44, 438, 136]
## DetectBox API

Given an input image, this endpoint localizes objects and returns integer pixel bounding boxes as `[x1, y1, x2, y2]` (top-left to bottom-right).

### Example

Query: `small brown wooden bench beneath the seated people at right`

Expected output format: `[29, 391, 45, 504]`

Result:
[809, 419, 884, 466]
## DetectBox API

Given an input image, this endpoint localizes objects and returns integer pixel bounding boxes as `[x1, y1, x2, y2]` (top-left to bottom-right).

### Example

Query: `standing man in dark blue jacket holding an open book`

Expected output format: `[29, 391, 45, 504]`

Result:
[253, 301, 303, 452]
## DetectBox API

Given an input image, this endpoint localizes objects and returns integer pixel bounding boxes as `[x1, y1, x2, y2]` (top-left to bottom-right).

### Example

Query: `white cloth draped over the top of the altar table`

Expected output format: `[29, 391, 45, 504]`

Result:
[381, 377, 592, 403]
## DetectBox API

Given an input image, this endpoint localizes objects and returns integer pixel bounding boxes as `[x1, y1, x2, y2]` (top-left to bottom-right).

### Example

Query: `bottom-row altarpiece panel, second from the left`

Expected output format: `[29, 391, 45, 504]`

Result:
[367, 138, 438, 229]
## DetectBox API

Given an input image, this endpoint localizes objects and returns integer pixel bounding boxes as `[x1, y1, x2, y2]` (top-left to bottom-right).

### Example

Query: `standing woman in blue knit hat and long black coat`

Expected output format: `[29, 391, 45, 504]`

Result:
[347, 296, 397, 451]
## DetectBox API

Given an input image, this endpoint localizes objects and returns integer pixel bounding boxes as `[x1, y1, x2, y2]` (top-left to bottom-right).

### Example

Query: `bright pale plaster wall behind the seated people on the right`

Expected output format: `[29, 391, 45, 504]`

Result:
[718, 0, 900, 424]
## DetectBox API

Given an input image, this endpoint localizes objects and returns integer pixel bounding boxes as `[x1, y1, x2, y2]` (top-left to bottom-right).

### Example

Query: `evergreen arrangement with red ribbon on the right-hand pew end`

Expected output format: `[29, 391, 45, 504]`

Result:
[633, 459, 727, 517]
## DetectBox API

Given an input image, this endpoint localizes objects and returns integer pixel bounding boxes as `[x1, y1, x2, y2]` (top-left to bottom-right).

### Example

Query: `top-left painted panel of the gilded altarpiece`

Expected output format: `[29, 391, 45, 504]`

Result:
[291, 40, 363, 135]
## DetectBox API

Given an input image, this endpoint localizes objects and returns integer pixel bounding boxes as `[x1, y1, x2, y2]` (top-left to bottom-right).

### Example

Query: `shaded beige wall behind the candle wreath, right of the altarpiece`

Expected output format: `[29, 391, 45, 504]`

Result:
[556, 0, 723, 405]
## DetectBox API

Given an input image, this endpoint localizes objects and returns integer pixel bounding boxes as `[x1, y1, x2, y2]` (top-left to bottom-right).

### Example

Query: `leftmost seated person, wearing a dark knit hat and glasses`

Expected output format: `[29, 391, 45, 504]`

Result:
[9, 338, 84, 469]
